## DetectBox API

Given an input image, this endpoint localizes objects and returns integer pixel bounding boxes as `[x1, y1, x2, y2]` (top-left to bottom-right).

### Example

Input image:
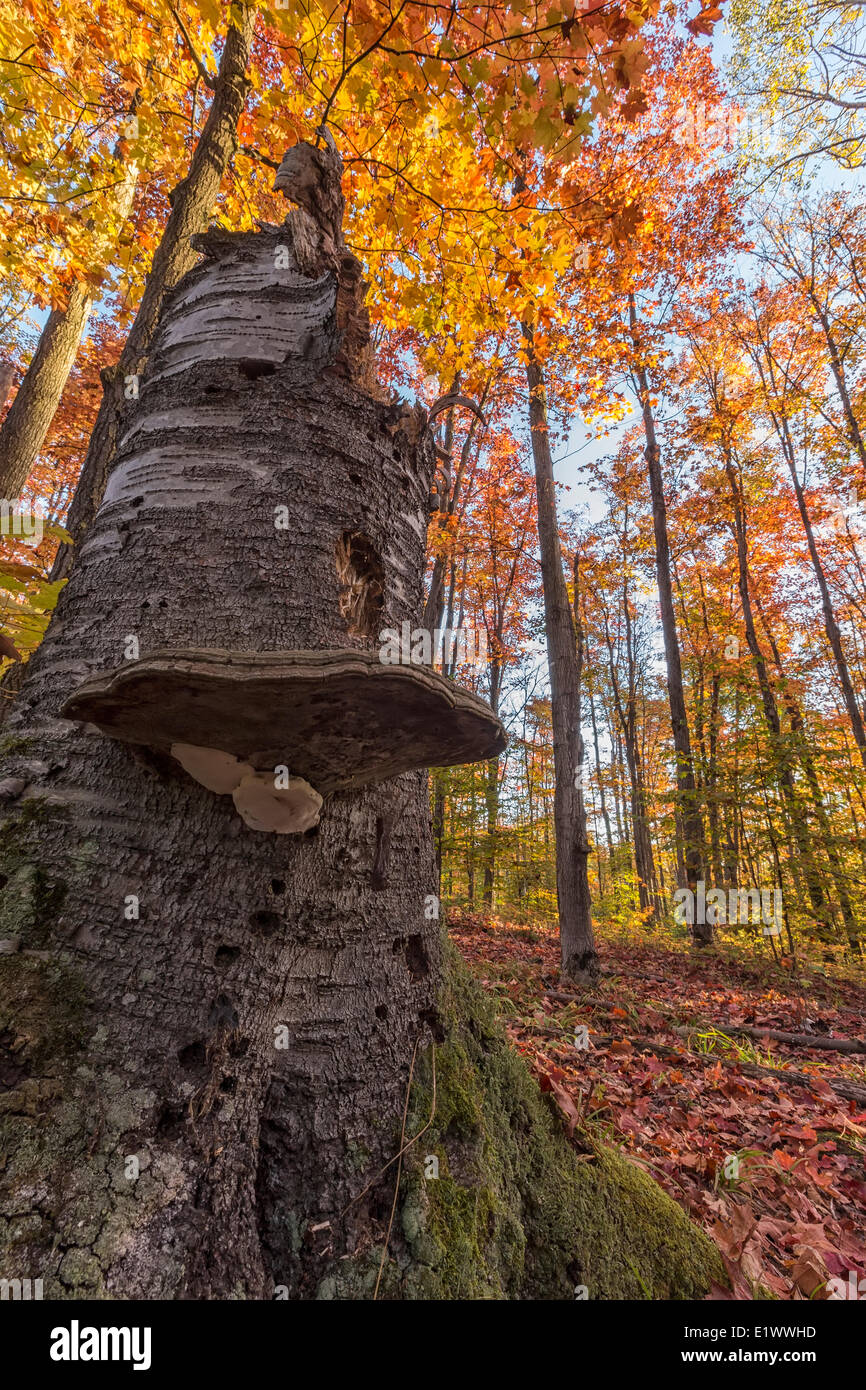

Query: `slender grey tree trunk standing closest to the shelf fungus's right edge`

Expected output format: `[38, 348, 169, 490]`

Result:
[521, 324, 598, 980]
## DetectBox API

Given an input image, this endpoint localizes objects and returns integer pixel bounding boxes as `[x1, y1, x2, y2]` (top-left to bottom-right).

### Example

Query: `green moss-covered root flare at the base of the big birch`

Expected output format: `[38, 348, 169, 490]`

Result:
[320, 948, 726, 1300]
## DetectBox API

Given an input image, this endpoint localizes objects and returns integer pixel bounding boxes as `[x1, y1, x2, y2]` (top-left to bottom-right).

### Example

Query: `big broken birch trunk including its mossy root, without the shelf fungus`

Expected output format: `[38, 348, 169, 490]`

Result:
[0, 182, 720, 1298]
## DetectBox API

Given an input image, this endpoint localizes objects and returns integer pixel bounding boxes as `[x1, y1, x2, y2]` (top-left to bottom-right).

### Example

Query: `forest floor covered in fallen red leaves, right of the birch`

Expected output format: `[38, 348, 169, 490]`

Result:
[449, 910, 866, 1300]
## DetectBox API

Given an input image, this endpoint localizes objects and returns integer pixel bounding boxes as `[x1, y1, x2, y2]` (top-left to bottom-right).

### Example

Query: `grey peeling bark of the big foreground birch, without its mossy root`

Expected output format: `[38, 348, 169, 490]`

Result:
[0, 211, 447, 1297]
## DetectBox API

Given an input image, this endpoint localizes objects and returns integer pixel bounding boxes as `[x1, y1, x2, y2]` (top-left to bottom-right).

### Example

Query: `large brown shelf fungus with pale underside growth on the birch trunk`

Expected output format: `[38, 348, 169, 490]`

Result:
[61, 649, 505, 834]
